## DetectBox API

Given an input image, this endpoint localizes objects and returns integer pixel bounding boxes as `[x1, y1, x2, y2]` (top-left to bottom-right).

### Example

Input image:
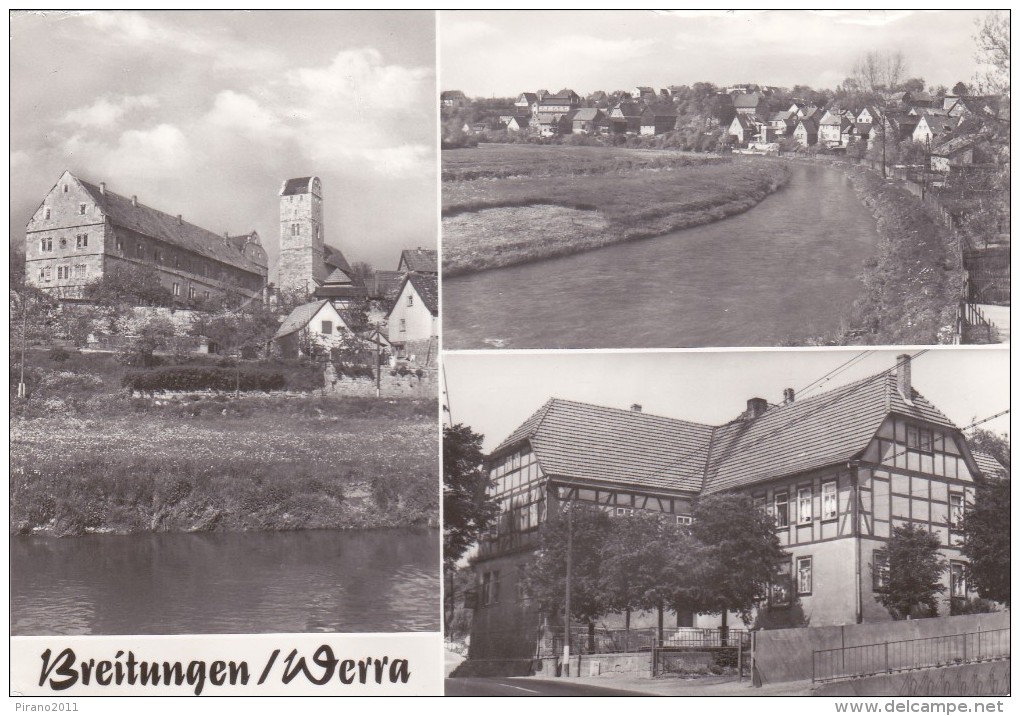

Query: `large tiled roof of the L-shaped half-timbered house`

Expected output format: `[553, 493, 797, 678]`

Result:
[493, 372, 956, 493]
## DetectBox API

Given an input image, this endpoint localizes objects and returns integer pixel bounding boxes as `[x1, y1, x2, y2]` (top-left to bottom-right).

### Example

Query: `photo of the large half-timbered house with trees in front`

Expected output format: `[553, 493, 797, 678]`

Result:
[443, 347, 1011, 697]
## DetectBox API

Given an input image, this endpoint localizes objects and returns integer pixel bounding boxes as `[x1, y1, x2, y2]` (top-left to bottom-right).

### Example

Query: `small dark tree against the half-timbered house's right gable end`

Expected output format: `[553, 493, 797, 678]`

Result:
[877, 525, 947, 619]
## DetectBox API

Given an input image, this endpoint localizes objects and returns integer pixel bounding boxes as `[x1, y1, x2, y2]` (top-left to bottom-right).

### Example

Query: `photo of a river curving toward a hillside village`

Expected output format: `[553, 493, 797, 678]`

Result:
[439, 10, 1010, 350]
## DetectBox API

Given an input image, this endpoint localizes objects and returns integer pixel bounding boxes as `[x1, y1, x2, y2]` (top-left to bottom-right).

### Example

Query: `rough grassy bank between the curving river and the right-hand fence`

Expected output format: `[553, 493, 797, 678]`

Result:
[803, 165, 965, 345]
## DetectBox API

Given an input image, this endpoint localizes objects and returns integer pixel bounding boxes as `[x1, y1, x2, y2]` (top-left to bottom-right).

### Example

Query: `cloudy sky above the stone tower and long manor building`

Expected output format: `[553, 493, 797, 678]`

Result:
[10, 11, 437, 281]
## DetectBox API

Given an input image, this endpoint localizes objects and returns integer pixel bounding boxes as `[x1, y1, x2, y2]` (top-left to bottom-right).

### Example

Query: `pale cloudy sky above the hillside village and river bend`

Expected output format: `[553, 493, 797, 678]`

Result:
[440, 10, 981, 97]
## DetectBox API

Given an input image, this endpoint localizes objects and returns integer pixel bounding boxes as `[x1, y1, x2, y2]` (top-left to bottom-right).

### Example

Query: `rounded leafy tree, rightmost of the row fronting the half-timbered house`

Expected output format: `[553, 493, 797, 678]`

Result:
[684, 493, 789, 624]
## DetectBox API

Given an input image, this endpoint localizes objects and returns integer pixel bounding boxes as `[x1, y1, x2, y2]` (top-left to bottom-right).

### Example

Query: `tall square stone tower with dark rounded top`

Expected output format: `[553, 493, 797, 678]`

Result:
[276, 176, 326, 294]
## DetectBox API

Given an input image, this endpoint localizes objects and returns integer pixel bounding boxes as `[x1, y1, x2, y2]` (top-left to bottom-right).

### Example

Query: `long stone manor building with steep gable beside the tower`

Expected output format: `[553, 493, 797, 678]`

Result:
[26, 171, 269, 305]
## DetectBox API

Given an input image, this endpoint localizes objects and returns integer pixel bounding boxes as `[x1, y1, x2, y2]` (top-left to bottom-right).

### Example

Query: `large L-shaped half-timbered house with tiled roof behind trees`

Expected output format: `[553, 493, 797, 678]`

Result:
[470, 355, 1003, 659]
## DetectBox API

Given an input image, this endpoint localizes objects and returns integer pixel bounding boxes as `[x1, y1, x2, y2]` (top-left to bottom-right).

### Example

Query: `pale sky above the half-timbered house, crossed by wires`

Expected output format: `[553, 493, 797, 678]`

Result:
[443, 348, 1010, 450]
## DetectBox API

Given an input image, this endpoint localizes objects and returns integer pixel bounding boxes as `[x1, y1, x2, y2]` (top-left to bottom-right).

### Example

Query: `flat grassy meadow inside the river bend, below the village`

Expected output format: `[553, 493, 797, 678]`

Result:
[443, 145, 789, 276]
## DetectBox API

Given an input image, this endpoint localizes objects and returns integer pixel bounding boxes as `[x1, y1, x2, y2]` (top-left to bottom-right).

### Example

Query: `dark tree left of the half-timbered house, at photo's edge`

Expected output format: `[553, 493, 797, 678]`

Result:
[443, 423, 498, 570]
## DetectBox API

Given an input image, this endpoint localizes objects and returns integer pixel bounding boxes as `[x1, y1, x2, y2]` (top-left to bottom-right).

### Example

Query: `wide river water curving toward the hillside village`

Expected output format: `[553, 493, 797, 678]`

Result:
[443, 162, 877, 349]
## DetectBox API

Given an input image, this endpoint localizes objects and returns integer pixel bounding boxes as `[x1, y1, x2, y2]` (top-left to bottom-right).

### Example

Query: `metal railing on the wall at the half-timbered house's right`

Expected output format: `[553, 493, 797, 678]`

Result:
[811, 627, 1010, 683]
